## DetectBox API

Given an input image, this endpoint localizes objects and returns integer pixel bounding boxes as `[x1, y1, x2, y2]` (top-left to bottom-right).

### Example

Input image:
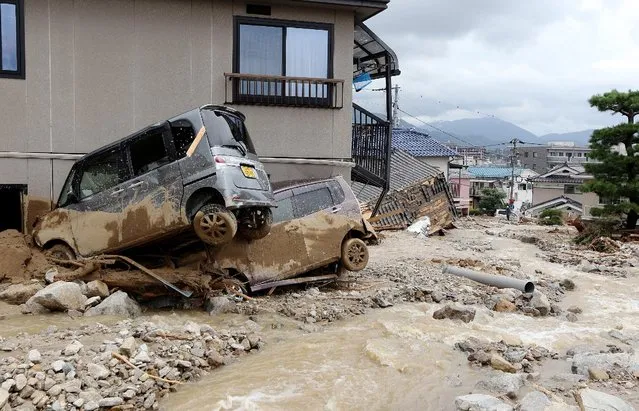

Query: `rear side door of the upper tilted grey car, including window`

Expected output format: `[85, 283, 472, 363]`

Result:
[122, 122, 185, 246]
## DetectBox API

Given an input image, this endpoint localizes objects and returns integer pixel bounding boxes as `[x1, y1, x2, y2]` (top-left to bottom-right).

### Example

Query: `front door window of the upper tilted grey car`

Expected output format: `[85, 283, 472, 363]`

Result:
[79, 150, 126, 199]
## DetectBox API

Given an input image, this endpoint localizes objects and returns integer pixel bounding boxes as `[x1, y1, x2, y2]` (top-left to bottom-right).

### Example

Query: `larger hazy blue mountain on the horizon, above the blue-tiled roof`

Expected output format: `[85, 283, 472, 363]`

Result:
[402, 117, 542, 146]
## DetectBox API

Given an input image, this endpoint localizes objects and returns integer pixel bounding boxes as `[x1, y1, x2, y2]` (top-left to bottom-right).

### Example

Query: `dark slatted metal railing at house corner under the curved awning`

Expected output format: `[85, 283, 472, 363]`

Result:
[351, 104, 391, 185]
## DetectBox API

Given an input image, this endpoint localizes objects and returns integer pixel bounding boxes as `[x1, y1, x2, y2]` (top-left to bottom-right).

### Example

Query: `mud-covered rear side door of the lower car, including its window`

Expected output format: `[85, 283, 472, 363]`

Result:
[294, 181, 348, 268]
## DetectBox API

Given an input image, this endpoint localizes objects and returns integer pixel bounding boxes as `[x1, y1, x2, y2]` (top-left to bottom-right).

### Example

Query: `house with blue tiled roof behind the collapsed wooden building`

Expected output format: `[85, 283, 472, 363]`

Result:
[393, 128, 459, 180]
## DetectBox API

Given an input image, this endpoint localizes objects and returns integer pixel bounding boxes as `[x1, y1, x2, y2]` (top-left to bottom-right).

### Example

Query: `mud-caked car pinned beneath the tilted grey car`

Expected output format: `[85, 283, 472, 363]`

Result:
[213, 177, 371, 291]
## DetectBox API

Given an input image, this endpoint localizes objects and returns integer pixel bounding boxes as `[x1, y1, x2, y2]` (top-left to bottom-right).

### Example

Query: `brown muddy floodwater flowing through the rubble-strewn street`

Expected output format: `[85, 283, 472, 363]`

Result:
[0, 222, 639, 410]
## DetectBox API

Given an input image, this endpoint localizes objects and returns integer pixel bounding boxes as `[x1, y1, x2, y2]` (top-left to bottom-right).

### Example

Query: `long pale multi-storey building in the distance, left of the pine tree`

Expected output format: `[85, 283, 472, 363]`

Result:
[517, 141, 590, 173]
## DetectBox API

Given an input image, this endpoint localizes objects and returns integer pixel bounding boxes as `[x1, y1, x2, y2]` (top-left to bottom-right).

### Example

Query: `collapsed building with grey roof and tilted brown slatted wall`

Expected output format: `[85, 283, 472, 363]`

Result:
[351, 148, 455, 233]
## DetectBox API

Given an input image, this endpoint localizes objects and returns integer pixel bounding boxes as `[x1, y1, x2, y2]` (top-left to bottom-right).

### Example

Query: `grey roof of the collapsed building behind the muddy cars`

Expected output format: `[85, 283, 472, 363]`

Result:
[351, 149, 442, 202]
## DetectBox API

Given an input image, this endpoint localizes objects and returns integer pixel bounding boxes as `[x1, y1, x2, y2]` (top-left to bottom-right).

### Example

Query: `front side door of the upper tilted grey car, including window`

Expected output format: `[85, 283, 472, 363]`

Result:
[66, 146, 129, 256]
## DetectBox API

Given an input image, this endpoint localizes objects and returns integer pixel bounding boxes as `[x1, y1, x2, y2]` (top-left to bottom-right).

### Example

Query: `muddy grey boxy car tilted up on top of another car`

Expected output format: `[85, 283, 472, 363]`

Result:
[34, 106, 275, 258]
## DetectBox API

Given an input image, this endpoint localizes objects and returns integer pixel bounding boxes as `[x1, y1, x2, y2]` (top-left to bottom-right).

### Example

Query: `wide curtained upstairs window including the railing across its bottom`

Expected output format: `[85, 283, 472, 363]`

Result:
[226, 18, 344, 108]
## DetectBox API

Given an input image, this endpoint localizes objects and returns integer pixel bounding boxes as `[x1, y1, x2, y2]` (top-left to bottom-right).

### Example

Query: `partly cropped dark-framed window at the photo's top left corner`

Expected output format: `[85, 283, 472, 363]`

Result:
[0, 0, 24, 78]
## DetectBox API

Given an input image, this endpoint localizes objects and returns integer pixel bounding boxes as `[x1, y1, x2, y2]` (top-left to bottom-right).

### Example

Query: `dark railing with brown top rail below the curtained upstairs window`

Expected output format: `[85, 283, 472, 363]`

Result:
[224, 73, 344, 109]
